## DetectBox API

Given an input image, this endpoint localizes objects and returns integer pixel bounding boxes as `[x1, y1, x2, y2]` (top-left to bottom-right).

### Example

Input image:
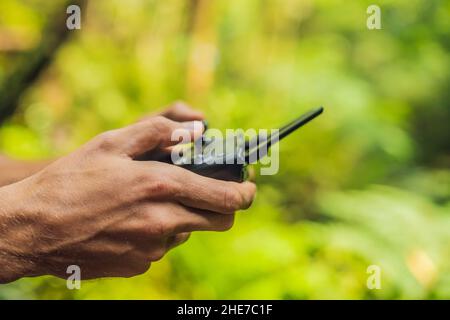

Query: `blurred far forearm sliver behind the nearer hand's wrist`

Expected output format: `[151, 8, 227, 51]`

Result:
[0, 155, 51, 187]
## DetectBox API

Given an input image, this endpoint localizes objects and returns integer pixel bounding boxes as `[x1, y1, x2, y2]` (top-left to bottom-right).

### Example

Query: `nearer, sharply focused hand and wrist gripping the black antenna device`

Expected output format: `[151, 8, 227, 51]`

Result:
[0, 109, 255, 282]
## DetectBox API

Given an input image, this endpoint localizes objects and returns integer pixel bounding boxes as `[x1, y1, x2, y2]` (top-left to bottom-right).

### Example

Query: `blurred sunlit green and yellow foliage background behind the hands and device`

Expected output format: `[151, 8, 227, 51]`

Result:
[0, 0, 450, 299]
